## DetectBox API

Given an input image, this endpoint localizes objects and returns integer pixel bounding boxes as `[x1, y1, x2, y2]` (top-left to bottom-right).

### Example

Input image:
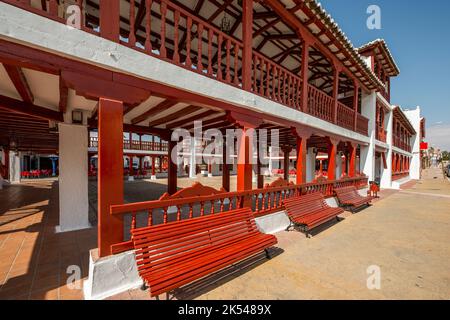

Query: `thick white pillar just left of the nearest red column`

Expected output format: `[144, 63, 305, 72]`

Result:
[57, 123, 90, 232]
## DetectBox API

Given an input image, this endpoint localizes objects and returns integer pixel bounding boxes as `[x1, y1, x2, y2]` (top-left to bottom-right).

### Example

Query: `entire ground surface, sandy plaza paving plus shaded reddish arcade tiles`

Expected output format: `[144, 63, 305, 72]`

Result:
[0, 169, 450, 299]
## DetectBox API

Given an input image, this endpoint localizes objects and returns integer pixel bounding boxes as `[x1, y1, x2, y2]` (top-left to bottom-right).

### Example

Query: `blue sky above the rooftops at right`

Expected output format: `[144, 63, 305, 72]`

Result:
[319, 0, 450, 150]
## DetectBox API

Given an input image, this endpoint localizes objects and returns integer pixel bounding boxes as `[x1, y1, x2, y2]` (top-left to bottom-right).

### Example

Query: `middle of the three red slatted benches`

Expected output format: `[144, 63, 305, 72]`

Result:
[284, 192, 344, 238]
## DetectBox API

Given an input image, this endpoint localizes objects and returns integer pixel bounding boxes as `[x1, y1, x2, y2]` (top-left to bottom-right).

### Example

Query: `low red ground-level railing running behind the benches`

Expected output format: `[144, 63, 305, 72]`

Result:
[111, 177, 368, 254]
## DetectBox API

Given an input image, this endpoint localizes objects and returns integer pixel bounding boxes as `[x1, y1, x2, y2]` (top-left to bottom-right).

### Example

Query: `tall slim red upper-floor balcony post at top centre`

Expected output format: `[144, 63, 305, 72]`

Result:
[242, 0, 253, 91]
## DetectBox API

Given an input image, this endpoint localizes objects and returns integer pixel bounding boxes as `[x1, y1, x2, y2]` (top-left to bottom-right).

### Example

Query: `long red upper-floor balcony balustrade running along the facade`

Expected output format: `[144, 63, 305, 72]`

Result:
[0, 0, 368, 136]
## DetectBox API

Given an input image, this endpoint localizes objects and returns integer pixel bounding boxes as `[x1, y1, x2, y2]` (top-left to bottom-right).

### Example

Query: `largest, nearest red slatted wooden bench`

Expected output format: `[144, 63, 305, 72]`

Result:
[131, 208, 277, 297]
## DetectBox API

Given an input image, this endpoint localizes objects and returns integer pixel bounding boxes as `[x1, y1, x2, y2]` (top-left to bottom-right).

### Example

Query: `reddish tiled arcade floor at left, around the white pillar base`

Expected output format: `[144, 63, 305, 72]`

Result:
[0, 181, 97, 299]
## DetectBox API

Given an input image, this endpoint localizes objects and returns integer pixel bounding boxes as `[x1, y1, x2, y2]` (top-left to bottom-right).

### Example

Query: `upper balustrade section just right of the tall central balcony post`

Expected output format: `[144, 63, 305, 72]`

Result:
[252, 52, 302, 110]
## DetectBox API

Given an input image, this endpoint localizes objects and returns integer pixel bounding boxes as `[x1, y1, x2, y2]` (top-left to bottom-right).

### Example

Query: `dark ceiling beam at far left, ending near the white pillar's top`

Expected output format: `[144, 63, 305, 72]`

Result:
[0, 95, 64, 122]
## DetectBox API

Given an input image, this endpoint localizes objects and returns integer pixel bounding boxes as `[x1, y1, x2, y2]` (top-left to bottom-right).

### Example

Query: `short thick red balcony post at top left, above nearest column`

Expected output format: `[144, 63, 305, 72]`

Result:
[99, 0, 120, 42]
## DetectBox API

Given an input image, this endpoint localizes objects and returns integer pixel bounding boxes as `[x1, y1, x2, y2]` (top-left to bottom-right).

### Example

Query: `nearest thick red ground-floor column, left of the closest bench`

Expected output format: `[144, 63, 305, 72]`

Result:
[98, 99, 124, 257]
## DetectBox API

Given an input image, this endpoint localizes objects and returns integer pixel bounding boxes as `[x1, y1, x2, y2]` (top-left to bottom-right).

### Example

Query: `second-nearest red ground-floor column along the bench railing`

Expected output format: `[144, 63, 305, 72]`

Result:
[237, 127, 253, 207]
